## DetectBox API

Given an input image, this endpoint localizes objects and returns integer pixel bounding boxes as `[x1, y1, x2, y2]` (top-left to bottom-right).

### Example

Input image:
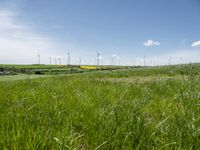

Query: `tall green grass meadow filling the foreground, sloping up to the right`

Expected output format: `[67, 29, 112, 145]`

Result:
[0, 64, 200, 150]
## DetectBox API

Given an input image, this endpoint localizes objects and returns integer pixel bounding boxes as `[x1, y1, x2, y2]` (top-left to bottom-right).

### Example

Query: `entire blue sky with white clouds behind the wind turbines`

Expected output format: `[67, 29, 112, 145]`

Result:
[0, 0, 200, 64]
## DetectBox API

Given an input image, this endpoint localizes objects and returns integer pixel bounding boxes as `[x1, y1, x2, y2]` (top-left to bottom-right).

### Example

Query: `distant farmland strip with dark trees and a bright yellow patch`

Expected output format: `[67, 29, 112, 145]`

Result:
[0, 64, 125, 76]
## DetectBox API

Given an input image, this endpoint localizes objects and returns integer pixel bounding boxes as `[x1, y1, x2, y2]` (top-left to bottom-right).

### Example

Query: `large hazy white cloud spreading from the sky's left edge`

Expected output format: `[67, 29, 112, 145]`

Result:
[0, 8, 67, 64]
